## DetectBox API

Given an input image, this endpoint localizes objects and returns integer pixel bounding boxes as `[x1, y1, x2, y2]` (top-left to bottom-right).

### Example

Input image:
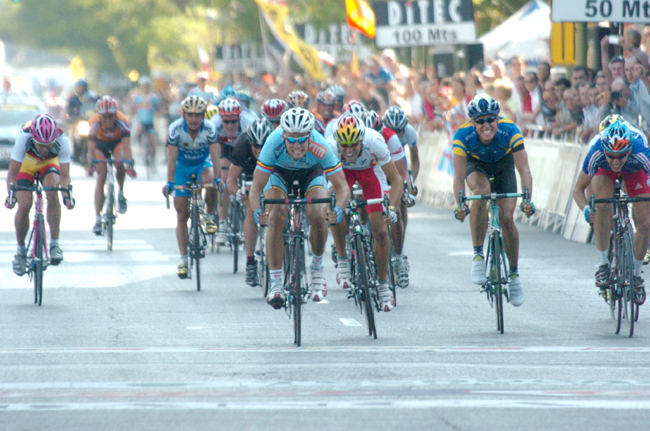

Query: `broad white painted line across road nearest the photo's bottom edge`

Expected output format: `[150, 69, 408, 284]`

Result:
[0, 399, 650, 411]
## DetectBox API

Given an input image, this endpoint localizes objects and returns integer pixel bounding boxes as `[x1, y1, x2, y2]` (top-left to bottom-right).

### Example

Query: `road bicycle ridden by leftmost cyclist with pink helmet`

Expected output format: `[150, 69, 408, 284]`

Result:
[8, 173, 74, 306]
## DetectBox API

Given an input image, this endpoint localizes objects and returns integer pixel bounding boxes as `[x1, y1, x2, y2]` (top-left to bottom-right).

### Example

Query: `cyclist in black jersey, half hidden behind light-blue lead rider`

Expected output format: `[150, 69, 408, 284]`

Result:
[226, 118, 273, 286]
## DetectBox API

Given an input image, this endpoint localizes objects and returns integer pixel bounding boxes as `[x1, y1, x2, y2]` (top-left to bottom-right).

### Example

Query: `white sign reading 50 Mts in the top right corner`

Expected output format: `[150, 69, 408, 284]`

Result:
[551, 0, 650, 23]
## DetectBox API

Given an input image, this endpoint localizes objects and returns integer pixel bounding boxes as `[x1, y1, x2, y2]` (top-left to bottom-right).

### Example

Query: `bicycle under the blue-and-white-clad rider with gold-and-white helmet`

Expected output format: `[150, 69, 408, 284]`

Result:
[165, 175, 214, 291]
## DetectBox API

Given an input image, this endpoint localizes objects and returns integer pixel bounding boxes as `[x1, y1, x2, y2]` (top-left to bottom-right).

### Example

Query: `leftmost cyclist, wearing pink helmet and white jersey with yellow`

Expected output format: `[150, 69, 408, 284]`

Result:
[5, 114, 74, 275]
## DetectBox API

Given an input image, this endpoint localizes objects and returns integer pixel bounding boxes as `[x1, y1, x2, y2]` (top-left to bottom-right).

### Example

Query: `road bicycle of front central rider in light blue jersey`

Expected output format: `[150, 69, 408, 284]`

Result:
[260, 181, 336, 346]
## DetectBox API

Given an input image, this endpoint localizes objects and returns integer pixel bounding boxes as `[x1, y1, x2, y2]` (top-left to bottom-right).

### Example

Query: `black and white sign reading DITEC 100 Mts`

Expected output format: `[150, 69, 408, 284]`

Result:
[372, 0, 476, 48]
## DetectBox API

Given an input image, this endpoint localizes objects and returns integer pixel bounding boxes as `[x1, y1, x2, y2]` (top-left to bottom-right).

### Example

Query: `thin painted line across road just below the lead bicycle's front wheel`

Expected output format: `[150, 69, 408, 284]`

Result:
[0, 346, 650, 354]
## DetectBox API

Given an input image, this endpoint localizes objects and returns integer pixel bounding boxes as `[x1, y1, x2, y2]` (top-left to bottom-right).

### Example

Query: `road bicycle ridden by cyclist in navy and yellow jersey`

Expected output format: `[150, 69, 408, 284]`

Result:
[458, 181, 530, 334]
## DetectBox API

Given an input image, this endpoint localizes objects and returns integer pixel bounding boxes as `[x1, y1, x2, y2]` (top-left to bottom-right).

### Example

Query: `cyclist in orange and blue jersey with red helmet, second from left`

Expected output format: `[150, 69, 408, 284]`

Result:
[88, 96, 136, 235]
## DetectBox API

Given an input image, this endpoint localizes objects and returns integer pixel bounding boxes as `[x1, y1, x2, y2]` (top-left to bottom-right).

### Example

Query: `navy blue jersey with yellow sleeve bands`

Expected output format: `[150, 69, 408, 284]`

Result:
[452, 117, 524, 163]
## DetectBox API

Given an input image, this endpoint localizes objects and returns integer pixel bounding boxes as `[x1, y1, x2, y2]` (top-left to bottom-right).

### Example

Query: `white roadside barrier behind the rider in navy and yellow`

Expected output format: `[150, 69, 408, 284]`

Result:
[415, 131, 591, 242]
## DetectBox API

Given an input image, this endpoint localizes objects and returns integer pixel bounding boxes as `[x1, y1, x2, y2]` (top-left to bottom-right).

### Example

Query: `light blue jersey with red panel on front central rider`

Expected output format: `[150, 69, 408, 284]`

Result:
[256, 128, 341, 176]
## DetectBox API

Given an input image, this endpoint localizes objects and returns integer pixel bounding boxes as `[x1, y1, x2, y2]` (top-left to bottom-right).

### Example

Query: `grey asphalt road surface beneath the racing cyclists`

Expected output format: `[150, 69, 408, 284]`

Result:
[0, 160, 650, 431]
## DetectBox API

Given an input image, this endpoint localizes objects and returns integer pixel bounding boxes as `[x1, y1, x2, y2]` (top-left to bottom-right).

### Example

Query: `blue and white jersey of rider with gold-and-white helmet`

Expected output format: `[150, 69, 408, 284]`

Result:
[167, 118, 218, 166]
